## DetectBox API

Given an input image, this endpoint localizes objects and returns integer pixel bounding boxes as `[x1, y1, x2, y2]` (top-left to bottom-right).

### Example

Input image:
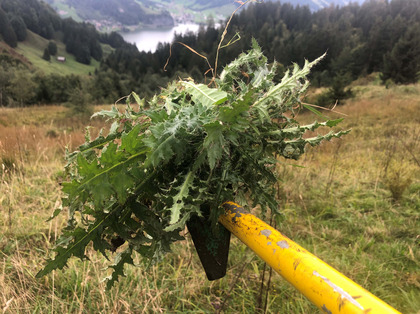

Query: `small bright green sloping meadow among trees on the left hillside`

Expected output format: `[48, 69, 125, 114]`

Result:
[16, 31, 99, 76]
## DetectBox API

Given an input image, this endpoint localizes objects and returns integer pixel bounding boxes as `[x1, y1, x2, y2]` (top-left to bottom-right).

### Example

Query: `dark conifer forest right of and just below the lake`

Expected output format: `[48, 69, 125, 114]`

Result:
[103, 0, 420, 99]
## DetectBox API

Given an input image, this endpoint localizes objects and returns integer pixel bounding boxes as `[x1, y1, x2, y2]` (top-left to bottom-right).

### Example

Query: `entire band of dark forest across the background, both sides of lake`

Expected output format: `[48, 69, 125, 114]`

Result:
[0, 0, 420, 106]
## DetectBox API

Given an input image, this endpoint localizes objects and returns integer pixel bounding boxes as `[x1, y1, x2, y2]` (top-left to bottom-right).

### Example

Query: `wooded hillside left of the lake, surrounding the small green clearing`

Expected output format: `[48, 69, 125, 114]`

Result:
[0, 0, 135, 106]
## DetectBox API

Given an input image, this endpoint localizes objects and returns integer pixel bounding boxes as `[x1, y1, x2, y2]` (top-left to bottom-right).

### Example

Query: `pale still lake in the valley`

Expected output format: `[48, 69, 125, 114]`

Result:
[120, 23, 200, 52]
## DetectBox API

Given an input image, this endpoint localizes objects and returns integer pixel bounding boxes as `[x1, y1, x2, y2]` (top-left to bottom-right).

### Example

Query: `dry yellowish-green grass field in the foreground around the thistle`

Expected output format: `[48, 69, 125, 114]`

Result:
[0, 85, 420, 313]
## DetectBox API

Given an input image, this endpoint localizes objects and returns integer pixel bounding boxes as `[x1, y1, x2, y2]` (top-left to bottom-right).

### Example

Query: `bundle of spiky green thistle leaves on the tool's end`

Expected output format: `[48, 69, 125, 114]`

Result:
[37, 41, 346, 287]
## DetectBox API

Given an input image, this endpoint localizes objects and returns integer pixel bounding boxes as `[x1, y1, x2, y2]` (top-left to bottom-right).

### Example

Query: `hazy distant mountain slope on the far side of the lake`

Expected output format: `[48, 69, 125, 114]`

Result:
[46, 0, 365, 31]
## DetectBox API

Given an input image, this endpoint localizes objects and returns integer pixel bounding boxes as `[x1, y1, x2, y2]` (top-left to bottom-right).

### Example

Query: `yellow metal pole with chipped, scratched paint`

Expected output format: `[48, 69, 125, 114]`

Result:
[219, 202, 399, 314]
